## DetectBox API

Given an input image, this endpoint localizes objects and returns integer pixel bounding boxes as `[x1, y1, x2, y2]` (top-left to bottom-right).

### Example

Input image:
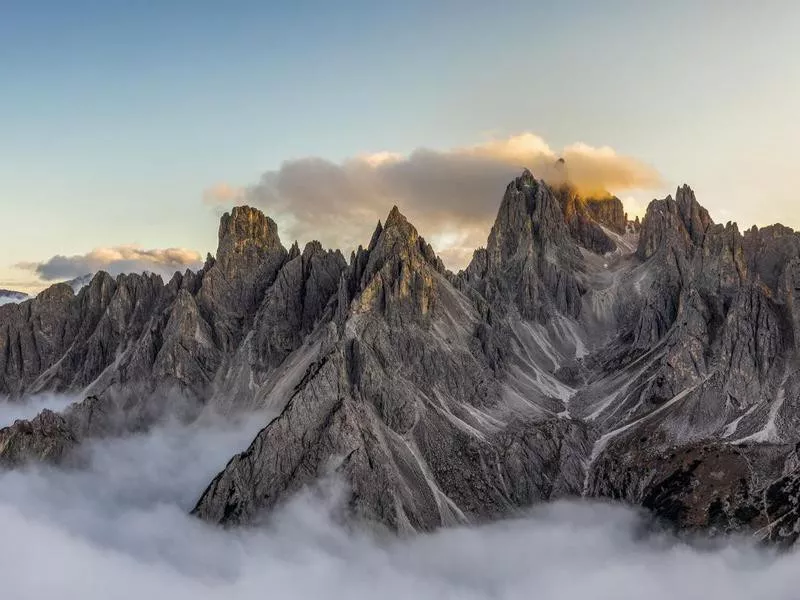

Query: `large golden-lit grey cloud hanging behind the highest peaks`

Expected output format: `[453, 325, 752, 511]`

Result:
[203, 133, 660, 269]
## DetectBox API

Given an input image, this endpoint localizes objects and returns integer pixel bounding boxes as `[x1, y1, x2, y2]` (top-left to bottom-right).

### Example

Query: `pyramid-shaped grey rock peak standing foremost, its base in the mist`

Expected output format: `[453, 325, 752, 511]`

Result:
[195, 209, 591, 530]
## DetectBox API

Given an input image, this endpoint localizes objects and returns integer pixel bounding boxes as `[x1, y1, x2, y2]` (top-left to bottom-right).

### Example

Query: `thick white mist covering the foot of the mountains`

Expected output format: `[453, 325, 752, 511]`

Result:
[0, 397, 800, 600]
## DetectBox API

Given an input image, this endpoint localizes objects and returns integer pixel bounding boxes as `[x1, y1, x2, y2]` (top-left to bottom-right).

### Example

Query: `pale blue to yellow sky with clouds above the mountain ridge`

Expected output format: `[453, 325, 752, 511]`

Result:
[0, 0, 800, 292]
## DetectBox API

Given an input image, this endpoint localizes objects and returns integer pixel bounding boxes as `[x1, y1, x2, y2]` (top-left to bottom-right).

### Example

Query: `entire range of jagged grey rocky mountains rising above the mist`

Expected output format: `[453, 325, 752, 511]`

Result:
[0, 171, 800, 545]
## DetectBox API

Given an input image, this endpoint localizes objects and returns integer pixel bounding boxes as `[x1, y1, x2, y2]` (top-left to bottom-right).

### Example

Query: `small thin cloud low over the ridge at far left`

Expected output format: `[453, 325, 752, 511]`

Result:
[16, 245, 203, 281]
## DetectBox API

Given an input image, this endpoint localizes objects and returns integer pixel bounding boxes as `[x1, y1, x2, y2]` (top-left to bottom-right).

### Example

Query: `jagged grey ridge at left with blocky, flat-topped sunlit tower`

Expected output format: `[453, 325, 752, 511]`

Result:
[0, 207, 344, 399]
